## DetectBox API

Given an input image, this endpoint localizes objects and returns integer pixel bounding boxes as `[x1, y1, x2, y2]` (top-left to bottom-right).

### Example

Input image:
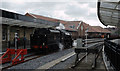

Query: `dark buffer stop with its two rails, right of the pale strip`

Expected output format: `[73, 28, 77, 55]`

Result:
[72, 42, 103, 69]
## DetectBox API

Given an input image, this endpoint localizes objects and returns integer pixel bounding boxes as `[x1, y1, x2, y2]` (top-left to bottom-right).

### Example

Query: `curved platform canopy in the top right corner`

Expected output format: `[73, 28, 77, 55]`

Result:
[98, 0, 120, 26]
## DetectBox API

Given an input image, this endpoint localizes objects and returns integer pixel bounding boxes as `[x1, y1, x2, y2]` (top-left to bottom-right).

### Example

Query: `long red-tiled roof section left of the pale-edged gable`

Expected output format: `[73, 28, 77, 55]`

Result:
[25, 13, 80, 39]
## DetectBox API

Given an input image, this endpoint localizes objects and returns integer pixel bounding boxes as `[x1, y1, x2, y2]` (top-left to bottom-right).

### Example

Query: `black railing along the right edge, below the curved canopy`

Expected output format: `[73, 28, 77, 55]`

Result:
[104, 40, 120, 71]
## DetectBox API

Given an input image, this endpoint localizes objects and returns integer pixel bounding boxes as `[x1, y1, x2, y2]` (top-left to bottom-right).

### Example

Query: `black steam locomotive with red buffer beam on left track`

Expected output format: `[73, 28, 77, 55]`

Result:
[30, 28, 73, 52]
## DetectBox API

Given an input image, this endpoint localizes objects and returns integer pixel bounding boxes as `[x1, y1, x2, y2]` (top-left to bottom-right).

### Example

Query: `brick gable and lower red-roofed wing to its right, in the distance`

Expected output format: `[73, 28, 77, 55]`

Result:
[79, 23, 111, 38]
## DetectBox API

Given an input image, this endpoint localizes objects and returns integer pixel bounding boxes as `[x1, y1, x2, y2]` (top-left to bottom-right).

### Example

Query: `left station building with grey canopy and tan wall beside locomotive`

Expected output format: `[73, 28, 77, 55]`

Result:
[0, 9, 59, 51]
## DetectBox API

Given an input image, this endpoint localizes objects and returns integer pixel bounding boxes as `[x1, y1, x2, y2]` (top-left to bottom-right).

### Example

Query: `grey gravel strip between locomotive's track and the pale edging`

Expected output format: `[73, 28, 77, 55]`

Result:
[9, 48, 74, 69]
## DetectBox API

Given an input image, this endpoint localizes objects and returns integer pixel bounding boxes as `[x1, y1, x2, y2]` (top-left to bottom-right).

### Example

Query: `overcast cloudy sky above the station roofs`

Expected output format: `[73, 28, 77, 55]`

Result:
[0, 0, 104, 27]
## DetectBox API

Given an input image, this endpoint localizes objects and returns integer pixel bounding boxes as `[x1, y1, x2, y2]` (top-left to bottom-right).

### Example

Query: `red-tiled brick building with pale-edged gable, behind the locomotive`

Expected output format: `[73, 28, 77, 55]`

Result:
[25, 13, 110, 39]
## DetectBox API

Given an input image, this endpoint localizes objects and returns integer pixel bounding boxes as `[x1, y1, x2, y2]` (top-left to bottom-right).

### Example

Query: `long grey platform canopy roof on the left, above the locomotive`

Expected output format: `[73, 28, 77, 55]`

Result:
[0, 9, 59, 28]
